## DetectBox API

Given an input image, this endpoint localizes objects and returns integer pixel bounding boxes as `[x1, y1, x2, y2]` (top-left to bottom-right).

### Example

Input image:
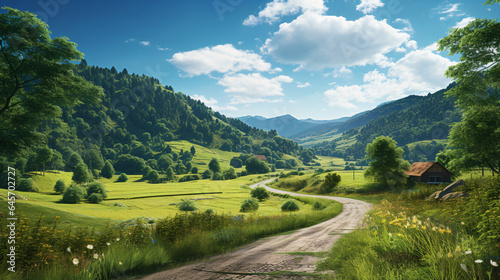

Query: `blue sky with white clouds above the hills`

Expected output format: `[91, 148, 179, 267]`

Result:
[4, 0, 500, 119]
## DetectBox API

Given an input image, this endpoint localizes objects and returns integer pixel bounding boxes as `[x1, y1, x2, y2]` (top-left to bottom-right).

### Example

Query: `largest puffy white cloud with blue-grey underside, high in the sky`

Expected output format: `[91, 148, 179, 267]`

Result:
[261, 13, 410, 70]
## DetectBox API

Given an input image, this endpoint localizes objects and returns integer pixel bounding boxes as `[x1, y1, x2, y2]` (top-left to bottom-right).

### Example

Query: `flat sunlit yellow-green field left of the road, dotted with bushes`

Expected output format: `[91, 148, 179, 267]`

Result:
[0, 172, 322, 225]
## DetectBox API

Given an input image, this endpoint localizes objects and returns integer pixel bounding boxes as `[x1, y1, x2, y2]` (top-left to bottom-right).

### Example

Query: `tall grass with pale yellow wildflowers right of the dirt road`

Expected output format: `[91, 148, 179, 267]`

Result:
[318, 177, 500, 279]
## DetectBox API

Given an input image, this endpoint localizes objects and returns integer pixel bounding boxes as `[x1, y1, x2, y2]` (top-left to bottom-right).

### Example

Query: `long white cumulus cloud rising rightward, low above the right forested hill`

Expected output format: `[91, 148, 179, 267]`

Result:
[324, 50, 453, 109]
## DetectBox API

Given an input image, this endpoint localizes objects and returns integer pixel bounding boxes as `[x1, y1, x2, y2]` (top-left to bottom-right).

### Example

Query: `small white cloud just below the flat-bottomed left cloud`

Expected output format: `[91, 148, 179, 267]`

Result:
[217, 73, 293, 104]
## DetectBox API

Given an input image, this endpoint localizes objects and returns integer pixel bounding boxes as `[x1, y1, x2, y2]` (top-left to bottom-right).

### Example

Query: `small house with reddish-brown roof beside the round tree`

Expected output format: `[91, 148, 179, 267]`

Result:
[405, 162, 452, 184]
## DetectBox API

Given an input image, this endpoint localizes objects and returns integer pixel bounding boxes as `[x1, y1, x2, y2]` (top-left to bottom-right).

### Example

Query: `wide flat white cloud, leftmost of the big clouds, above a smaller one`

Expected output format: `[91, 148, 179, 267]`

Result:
[168, 44, 271, 76]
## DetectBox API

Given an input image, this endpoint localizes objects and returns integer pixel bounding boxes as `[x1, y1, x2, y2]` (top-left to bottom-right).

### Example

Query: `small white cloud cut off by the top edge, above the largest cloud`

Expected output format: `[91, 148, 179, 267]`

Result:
[243, 0, 328, 25]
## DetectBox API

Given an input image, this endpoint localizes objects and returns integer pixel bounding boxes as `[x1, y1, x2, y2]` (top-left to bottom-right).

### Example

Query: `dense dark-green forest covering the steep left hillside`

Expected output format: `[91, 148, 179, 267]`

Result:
[0, 60, 302, 182]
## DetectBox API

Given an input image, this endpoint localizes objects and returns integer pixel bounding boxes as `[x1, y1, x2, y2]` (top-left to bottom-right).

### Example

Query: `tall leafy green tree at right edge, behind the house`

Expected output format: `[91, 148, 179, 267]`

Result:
[438, 0, 500, 174]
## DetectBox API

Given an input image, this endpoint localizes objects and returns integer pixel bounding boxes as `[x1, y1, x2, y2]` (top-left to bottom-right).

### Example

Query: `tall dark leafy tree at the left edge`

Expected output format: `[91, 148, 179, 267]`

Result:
[0, 7, 103, 155]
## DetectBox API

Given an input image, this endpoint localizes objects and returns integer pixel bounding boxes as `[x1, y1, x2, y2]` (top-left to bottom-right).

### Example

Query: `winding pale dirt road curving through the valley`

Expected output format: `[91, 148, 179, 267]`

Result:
[140, 179, 371, 280]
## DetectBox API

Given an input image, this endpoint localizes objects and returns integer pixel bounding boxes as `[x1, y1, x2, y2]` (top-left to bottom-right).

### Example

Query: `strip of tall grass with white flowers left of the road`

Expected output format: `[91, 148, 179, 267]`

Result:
[0, 199, 342, 279]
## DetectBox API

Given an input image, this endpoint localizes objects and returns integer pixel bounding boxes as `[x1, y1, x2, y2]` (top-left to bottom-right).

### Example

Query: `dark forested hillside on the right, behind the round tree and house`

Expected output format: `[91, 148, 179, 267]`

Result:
[313, 84, 461, 161]
